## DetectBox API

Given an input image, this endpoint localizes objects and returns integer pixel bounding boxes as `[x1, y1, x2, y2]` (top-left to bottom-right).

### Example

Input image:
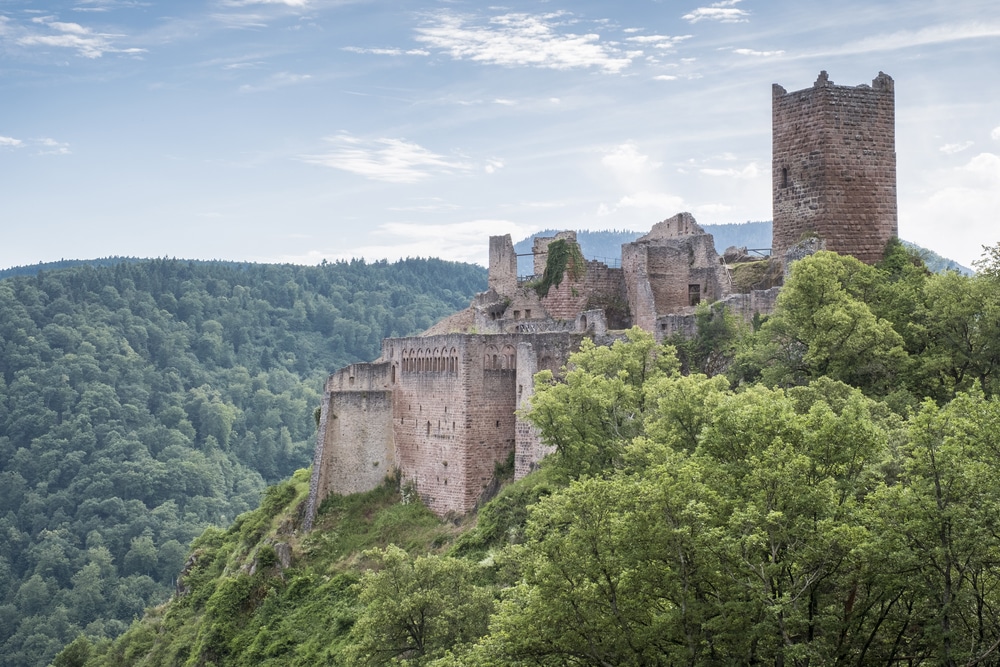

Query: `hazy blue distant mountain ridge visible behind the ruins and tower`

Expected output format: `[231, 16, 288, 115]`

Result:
[514, 220, 973, 275]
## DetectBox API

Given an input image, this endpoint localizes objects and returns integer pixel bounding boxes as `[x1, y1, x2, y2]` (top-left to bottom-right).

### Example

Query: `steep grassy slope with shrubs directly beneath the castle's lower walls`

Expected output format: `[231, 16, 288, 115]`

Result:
[72, 470, 553, 667]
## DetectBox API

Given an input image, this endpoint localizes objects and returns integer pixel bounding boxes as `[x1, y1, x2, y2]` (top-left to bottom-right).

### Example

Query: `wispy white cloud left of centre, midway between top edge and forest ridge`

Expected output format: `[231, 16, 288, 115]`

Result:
[300, 134, 473, 183]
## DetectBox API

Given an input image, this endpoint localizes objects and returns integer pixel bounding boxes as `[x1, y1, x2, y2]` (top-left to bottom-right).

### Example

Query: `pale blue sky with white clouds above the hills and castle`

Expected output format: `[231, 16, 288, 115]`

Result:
[0, 0, 1000, 268]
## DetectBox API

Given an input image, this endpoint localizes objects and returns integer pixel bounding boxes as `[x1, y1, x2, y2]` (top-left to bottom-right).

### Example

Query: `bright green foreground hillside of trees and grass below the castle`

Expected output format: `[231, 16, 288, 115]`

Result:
[56, 243, 1000, 667]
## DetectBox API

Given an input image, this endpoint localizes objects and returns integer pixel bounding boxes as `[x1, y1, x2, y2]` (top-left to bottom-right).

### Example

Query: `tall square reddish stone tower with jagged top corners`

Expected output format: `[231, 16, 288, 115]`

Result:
[771, 72, 898, 264]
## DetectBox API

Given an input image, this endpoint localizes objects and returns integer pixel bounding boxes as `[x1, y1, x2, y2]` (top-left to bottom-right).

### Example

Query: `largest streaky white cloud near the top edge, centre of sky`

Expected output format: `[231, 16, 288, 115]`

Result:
[416, 13, 632, 72]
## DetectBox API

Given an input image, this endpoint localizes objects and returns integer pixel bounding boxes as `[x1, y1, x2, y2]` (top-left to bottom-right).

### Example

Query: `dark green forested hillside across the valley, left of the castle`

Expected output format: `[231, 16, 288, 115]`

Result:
[0, 259, 486, 666]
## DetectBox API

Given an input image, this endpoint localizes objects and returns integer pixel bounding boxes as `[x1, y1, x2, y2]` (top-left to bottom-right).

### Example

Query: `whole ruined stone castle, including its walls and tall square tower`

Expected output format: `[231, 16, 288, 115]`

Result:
[306, 72, 896, 527]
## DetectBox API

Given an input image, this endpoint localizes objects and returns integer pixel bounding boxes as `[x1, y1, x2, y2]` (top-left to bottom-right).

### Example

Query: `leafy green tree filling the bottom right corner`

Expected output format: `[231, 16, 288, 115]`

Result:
[870, 393, 1000, 666]
